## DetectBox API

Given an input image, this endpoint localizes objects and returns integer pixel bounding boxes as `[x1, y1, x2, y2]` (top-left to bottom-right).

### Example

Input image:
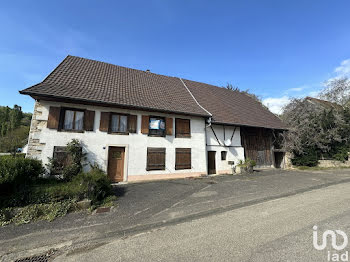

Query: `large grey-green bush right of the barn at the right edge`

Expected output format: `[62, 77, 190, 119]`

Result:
[282, 78, 350, 167]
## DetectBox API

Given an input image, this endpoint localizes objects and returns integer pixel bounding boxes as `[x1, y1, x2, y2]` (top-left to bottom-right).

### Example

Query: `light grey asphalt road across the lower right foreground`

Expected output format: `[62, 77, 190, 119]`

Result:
[54, 183, 350, 262]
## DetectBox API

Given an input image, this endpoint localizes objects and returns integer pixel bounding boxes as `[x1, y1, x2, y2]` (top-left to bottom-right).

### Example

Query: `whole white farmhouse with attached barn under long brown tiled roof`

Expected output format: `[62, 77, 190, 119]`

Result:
[20, 56, 285, 182]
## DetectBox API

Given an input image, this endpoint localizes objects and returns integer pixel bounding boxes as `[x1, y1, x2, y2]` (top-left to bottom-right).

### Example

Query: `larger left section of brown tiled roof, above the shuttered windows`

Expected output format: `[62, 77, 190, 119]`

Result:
[21, 56, 208, 116]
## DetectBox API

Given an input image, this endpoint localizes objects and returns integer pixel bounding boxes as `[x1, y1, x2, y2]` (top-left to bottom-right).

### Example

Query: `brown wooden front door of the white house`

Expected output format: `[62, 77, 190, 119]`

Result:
[108, 146, 125, 182]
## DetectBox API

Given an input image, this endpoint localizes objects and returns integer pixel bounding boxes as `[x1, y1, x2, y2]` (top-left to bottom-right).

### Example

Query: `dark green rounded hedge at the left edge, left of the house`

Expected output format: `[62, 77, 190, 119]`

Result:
[0, 157, 45, 192]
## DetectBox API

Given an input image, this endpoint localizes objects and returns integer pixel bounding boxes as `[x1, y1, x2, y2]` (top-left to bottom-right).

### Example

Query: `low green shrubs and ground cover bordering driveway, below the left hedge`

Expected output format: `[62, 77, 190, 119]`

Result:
[0, 170, 117, 226]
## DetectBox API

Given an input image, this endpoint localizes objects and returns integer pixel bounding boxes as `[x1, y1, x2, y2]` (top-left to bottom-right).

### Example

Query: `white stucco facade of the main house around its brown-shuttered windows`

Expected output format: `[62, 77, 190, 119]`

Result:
[33, 100, 207, 181]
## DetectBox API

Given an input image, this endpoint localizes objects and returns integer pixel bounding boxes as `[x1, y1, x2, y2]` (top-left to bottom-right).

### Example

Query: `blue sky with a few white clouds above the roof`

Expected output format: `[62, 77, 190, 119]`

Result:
[0, 0, 350, 113]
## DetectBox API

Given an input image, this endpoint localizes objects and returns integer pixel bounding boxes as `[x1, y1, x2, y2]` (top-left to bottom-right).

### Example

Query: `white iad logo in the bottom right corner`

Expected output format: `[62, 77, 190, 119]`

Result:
[313, 226, 349, 261]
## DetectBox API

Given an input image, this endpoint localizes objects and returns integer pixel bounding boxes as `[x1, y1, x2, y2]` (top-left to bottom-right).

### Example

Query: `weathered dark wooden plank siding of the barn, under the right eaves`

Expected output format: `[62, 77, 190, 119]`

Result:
[241, 127, 273, 166]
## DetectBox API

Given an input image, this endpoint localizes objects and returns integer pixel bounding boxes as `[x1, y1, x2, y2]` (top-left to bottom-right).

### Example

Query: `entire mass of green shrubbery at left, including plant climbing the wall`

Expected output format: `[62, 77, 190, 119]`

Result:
[0, 141, 115, 226]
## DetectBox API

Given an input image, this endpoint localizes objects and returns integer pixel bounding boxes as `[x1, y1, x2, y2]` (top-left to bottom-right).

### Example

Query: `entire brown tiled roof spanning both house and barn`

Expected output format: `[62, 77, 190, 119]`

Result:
[20, 56, 285, 129]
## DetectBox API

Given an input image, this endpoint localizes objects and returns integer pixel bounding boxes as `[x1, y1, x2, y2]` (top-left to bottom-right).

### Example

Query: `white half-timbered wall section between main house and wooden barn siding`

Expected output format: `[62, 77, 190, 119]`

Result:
[206, 124, 244, 173]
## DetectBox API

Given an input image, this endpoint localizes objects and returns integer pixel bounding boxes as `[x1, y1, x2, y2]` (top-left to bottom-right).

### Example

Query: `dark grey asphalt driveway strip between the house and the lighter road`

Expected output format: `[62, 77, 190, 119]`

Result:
[0, 169, 350, 257]
